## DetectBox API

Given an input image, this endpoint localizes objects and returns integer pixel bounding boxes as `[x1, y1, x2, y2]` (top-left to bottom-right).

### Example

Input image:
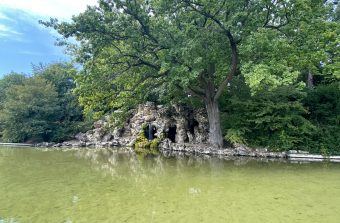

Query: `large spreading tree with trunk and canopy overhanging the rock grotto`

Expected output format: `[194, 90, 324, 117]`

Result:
[44, 0, 338, 147]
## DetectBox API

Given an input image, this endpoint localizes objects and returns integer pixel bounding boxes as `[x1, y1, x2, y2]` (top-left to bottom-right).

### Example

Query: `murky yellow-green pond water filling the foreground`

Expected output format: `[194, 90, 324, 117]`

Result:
[0, 148, 340, 223]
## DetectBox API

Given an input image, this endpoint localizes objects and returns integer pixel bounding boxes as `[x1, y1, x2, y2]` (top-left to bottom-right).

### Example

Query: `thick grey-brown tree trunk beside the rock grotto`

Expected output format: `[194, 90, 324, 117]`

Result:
[206, 100, 223, 148]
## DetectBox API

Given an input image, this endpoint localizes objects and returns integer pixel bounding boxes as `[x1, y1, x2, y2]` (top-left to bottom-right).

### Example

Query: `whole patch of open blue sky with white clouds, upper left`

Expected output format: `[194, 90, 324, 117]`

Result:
[0, 0, 96, 77]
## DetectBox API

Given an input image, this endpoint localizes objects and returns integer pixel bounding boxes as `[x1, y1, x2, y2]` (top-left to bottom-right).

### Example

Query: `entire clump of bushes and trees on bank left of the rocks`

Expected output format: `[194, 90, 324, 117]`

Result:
[0, 63, 91, 142]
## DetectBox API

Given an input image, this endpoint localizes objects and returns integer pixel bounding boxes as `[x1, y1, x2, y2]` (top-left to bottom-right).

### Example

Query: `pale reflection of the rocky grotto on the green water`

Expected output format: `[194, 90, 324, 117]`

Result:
[75, 147, 290, 186]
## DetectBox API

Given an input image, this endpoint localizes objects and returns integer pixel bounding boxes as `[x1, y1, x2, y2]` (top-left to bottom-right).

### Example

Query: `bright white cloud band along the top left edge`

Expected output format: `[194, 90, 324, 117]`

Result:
[0, 0, 97, 20]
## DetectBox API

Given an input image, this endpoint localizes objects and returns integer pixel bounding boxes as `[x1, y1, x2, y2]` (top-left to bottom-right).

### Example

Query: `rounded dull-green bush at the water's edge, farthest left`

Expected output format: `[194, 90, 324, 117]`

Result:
[0, 77, 59, 142]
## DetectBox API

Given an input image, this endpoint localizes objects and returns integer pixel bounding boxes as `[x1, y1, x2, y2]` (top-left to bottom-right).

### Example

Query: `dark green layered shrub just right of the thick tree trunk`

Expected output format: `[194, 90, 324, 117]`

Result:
[222, 83, 315, 151]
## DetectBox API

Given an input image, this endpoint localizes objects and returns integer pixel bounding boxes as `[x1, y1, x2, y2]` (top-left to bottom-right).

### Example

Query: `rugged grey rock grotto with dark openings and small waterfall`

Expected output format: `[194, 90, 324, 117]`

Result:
[55, 102, 209, 147]
